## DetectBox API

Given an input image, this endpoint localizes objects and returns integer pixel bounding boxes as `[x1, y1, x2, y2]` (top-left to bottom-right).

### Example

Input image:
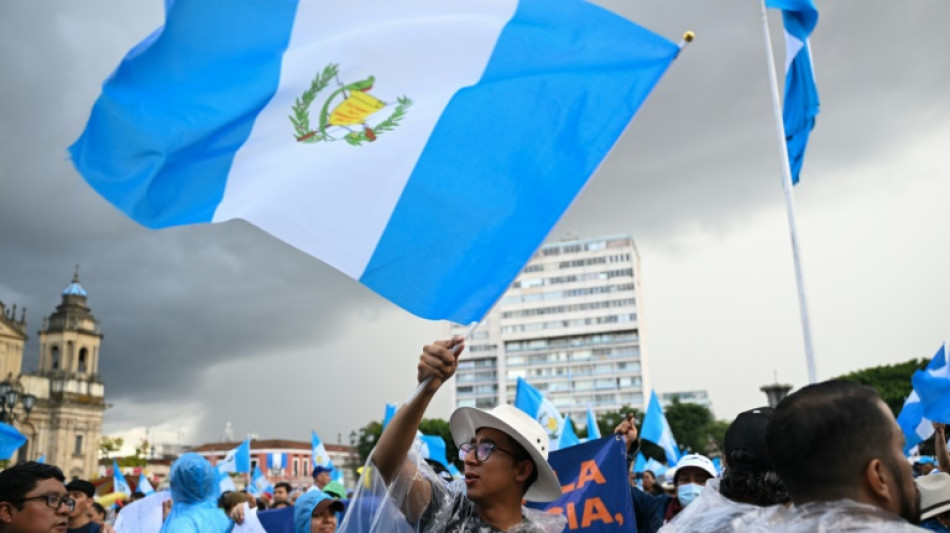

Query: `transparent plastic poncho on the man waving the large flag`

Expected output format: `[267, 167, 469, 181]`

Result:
[337, 446, 567, 533]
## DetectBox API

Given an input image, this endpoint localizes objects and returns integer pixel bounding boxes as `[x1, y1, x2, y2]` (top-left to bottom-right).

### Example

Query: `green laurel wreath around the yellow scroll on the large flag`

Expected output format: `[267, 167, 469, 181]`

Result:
[288, 63, 412, 146]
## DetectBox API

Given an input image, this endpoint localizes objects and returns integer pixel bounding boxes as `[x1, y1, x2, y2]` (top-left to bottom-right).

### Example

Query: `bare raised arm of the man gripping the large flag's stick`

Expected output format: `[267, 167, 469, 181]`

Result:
[373, 338, 464, 521]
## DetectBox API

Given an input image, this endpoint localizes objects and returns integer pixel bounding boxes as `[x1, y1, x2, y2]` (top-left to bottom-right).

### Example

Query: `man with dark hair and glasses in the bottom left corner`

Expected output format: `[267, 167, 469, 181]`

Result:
[0, 461, 76, 533]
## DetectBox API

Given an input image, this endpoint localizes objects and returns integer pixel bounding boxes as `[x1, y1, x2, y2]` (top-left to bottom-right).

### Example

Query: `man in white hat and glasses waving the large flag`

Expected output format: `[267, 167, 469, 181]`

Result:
[372, 338, 565, 533]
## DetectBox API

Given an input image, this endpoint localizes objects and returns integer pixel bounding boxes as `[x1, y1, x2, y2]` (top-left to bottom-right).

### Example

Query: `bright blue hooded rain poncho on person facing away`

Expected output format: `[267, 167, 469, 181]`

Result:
[161, 452, 232, 533]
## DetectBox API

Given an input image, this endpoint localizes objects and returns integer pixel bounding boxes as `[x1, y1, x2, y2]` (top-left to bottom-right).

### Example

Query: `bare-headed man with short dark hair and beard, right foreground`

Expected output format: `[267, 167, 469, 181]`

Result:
[766, 381, 920, 531]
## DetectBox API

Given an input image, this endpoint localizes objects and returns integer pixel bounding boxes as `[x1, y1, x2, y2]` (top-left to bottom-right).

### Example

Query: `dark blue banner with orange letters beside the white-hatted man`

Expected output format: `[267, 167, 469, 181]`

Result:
[526, 435, 637, 533]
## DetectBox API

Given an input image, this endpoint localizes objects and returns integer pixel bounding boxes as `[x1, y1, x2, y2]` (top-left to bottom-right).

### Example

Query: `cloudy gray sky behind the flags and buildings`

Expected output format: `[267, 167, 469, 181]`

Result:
[0, 0, 950, 443]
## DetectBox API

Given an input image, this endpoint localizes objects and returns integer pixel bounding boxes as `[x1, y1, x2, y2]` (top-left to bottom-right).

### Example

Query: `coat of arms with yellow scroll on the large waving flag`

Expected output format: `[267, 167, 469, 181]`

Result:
[290, 63, 412, 146]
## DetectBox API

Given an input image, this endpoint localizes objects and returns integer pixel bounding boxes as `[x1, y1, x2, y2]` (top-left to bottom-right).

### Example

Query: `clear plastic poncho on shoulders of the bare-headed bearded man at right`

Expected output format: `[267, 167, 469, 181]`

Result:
[740, 500, 926, 533]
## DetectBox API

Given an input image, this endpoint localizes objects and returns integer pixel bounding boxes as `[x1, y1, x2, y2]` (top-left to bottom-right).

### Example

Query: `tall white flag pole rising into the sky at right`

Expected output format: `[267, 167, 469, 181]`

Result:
[759, 0, 818, 383]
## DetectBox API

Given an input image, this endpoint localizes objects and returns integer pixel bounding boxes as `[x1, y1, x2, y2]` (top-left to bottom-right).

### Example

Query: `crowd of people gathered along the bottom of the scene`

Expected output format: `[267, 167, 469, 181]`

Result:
[0, 338, 950, 533]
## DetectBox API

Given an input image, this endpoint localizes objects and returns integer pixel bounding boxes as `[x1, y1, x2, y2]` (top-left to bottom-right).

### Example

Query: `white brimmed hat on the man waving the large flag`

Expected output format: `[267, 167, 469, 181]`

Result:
[449, 404, 561, 502]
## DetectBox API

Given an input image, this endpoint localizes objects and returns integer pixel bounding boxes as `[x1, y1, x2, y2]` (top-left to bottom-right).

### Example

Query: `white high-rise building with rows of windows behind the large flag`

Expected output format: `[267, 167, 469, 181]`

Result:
[449, 236, 649, 427]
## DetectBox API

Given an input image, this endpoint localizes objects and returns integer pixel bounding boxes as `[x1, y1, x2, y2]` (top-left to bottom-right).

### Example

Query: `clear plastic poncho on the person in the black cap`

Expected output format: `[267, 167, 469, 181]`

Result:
[659, 478, 762, 533]
